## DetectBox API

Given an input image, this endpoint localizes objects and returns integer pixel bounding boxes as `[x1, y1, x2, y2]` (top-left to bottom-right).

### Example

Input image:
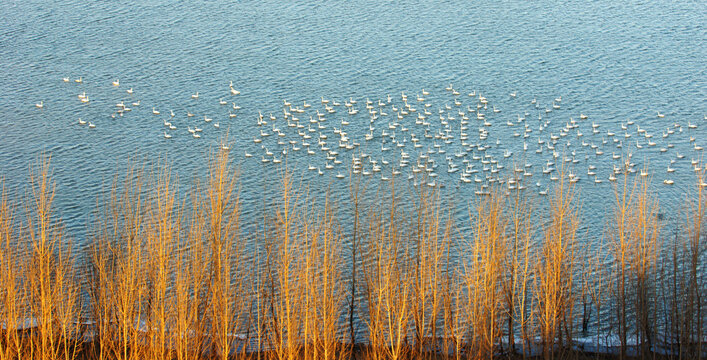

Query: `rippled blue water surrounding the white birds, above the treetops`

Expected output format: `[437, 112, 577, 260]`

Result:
[0, 1, 707, 242]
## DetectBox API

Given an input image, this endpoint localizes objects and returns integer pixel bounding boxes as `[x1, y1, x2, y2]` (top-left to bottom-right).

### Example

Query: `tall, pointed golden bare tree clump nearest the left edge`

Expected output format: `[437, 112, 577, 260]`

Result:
[23, 157, 81, 359]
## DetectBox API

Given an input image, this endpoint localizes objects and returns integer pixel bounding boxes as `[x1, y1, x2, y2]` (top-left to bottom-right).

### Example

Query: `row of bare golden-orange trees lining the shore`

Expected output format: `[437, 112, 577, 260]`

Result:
[0, 152, 707, 360]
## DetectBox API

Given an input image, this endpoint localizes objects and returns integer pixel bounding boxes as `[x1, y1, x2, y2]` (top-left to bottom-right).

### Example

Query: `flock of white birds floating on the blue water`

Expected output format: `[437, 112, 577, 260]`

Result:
[35, 78, 707, 195]
